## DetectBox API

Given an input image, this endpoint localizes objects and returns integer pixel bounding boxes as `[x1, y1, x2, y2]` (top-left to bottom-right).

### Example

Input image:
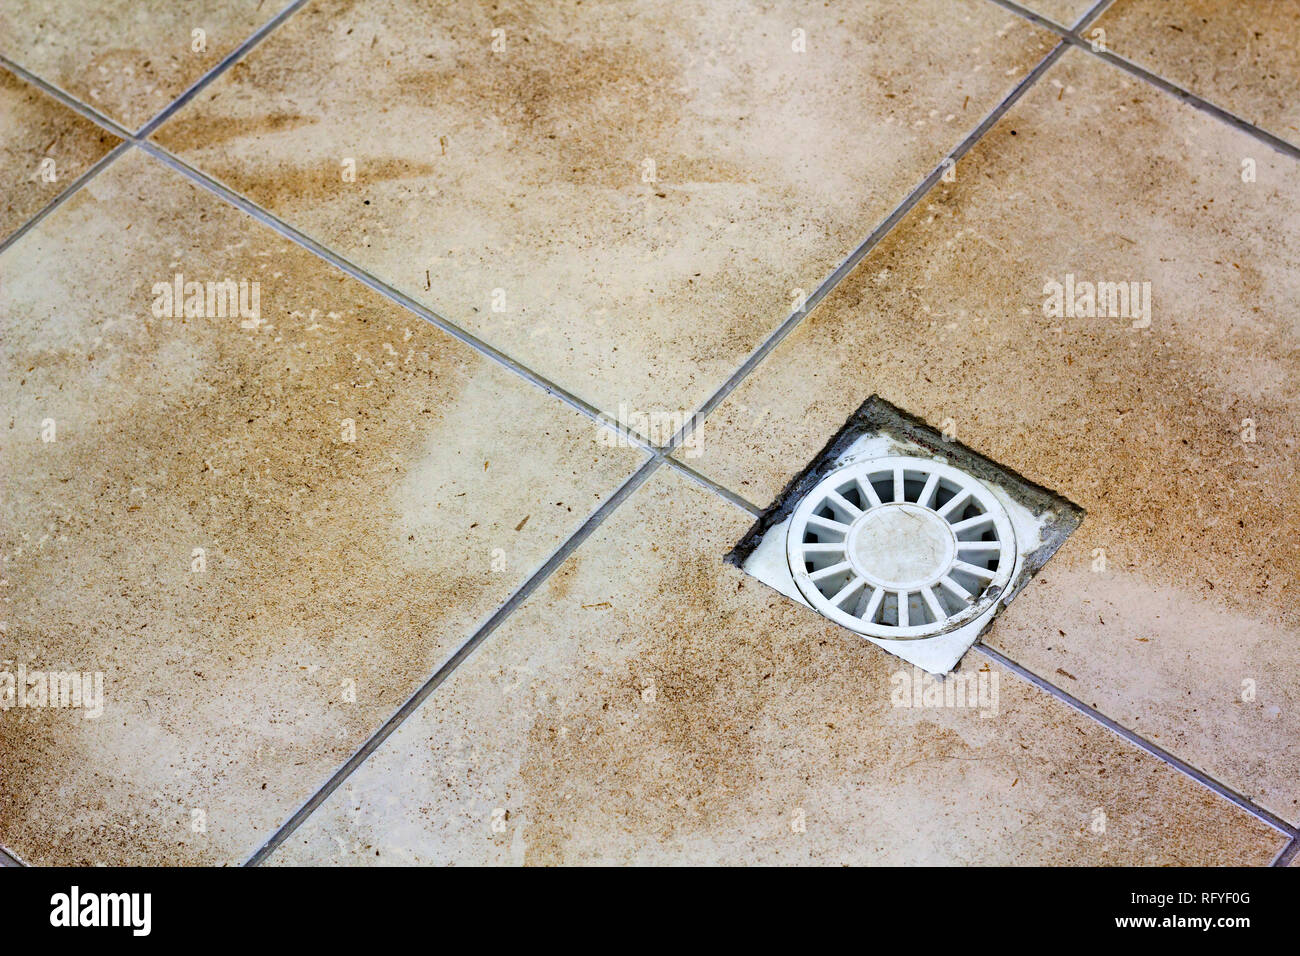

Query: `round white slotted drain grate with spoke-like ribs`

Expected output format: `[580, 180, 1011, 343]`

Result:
[787, 457, 1015, 640]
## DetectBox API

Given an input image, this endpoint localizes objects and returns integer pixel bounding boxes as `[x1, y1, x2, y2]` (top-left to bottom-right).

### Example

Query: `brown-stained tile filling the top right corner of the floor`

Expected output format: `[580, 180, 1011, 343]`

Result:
[1097, 0, 1300, 146]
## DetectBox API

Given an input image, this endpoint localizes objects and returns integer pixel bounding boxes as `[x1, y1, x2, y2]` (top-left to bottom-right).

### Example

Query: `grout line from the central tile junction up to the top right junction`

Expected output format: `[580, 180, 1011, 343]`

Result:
[666, 40, 1067, 453]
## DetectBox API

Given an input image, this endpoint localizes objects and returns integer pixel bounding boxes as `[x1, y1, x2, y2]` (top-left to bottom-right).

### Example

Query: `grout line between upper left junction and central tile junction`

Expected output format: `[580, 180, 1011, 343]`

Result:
[135, 139, 658, 453]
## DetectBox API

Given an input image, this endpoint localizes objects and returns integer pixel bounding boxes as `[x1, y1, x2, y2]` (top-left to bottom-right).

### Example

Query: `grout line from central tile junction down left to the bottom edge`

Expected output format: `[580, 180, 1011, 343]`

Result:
[244, 454, 663, 866]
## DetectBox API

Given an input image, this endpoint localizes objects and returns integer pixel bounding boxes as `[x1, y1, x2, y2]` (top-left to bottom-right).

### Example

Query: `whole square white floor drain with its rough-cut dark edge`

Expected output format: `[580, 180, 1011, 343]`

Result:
[725, 395, 1084, 674]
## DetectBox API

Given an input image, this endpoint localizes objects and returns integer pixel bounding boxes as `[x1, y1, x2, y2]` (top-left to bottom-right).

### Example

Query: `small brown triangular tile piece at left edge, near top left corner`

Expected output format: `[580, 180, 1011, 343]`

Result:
[0, 69, 121, 242]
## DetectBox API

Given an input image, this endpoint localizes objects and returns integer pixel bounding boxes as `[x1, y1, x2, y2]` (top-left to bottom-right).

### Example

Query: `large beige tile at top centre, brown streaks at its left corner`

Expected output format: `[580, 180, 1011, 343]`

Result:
[157, 0, 1053, 429]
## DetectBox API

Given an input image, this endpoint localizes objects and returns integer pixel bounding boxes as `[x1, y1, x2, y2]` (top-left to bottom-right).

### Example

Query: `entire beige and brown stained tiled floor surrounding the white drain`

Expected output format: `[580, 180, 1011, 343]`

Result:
[0, 0, 1300, 865]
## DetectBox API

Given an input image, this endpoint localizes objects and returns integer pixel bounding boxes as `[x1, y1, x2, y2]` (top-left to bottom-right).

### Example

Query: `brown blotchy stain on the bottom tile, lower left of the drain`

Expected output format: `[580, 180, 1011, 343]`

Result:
[520, 554, 780, 864]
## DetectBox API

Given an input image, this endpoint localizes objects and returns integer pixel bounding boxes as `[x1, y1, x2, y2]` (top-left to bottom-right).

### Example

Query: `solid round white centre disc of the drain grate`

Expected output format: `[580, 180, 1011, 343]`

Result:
[845, 503, 957, 589]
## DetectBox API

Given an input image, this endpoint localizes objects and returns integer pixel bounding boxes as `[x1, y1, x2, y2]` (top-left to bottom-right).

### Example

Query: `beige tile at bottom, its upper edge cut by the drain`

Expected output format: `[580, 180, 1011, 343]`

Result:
[272, 468, 1284, 864]
